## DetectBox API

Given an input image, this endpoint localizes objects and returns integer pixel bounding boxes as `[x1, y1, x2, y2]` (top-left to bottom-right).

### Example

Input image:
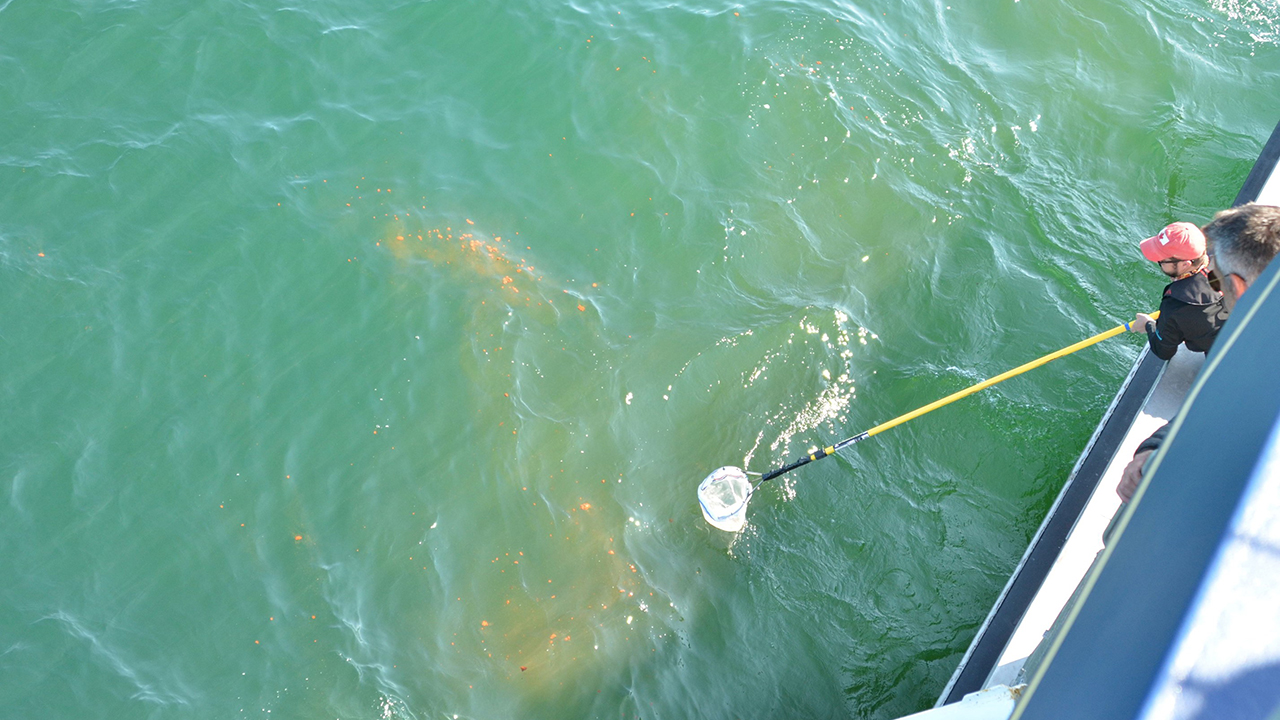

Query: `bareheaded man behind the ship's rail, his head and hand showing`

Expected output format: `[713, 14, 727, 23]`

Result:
[1116, 202, 1280, 502]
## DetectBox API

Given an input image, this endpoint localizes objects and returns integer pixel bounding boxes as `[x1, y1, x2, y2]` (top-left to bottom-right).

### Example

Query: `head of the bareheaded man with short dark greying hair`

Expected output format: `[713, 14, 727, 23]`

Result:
[1202, 202, 1280, 307]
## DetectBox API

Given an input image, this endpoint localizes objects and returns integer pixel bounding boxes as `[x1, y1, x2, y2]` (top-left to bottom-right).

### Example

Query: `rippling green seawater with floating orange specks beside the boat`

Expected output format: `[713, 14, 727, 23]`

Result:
[0, 0, 1280, 720]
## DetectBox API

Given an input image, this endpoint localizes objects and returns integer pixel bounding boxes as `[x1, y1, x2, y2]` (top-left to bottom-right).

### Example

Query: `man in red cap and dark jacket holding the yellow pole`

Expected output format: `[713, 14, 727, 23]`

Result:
[1126, 223, 1228, 360]
